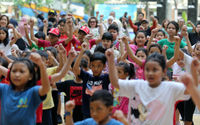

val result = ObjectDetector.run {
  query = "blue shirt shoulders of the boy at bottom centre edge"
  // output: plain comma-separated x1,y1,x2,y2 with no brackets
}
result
74,118,123,125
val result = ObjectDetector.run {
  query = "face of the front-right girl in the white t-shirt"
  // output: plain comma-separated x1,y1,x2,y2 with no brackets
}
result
144,61,165,87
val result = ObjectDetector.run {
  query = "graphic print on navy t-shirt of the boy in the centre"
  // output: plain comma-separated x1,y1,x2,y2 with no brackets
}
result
85,80,103,96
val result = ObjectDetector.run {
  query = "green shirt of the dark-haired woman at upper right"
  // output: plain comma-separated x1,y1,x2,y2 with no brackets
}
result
158,39,187,60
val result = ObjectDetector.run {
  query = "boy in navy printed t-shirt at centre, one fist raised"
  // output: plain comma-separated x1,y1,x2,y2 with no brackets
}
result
73,43,110,118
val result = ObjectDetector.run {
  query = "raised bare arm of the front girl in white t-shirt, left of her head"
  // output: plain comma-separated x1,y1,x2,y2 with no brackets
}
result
106,49,119,89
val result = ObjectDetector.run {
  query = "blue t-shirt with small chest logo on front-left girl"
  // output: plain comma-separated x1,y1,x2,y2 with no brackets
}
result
0,84,42,125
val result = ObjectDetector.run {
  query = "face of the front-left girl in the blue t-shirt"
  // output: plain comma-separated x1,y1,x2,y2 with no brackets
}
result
10,62,32,89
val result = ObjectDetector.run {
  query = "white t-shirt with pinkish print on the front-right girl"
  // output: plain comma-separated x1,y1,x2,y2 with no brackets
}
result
119,80,189,125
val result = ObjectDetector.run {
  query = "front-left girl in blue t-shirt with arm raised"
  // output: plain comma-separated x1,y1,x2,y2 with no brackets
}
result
0,53,50,125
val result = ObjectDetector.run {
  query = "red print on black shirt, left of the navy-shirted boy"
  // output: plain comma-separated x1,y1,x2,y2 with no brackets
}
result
70,86,82,105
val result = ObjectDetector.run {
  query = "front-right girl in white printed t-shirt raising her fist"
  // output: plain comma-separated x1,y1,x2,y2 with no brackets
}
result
106,49,192,125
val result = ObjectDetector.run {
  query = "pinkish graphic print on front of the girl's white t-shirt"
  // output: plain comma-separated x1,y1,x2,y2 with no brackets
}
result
130,94,166,125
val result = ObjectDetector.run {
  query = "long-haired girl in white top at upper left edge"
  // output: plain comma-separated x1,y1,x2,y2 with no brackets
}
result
0,27,18,55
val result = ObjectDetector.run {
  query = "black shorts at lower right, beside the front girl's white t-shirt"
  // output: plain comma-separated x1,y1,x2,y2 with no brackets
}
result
177,98,195,122
